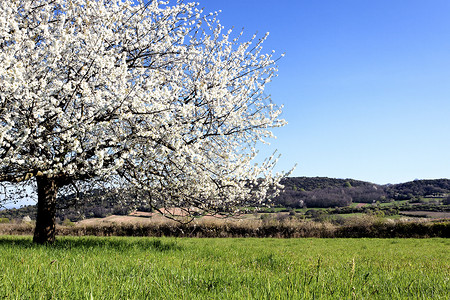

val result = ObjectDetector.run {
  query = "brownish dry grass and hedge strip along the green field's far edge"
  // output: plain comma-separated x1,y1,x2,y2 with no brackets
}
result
0,215,450,238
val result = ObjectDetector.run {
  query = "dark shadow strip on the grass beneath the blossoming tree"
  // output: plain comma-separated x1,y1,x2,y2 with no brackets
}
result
0,236,182,252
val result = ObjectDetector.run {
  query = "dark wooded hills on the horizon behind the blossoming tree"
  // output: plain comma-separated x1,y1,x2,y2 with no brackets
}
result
0,177,450,221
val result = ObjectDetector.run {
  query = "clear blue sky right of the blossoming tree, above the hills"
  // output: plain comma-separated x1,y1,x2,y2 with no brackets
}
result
200,0,450,184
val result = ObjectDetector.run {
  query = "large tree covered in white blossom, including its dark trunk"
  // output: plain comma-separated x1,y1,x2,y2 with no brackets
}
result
0,0,285,243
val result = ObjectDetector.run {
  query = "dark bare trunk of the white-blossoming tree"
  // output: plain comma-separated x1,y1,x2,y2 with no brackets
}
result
33,176,58,244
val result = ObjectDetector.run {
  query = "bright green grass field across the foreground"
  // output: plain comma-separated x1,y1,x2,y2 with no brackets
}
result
0,236,450,299
